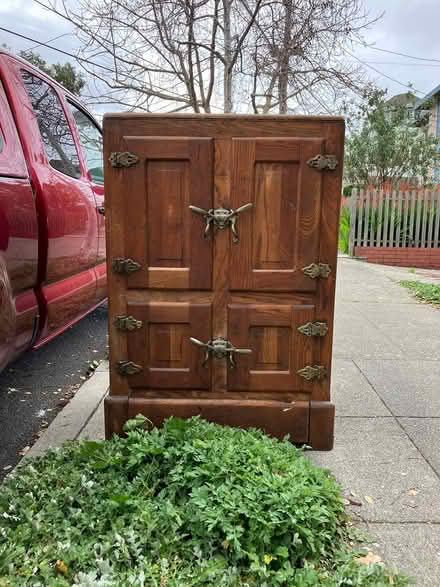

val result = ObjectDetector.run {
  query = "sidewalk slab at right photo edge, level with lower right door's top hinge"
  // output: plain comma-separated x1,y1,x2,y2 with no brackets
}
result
358,302,440,361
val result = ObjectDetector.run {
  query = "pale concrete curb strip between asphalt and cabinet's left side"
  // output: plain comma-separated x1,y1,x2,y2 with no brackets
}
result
20,361,109,468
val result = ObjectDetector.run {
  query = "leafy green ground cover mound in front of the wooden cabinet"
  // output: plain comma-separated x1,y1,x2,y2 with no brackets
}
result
0,416,409,587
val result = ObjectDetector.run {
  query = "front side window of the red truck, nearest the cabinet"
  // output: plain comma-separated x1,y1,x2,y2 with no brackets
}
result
68,102,104,184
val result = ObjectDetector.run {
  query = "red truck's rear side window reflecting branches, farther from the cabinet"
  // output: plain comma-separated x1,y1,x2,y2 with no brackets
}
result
21,70,81,178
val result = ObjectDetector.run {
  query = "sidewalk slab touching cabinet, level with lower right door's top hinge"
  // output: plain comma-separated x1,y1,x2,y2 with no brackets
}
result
333,302,403,359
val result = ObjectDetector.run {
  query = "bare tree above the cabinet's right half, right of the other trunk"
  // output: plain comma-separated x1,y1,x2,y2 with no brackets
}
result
249,0,370,114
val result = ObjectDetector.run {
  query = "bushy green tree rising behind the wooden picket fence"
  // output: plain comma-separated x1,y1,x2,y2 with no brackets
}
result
344,90,440,189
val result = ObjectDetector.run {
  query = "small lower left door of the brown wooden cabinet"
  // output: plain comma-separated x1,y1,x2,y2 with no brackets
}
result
125,302,211,389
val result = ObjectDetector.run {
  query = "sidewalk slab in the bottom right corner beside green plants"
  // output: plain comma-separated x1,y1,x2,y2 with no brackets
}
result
356,524,440,587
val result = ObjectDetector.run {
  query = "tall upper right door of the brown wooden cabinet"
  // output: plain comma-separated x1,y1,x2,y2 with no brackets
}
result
230,138,325,292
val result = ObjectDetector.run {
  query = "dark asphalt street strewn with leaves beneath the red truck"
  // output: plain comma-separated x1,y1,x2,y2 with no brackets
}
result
0,306,108,479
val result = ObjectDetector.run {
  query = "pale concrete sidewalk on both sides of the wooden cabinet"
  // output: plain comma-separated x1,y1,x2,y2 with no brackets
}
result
18,259,440,587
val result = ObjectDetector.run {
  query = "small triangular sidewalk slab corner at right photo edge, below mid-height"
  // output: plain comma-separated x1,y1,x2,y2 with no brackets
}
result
398,418,440,478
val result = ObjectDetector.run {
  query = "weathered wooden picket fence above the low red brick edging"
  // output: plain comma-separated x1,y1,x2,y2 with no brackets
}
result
347,190,440,255
